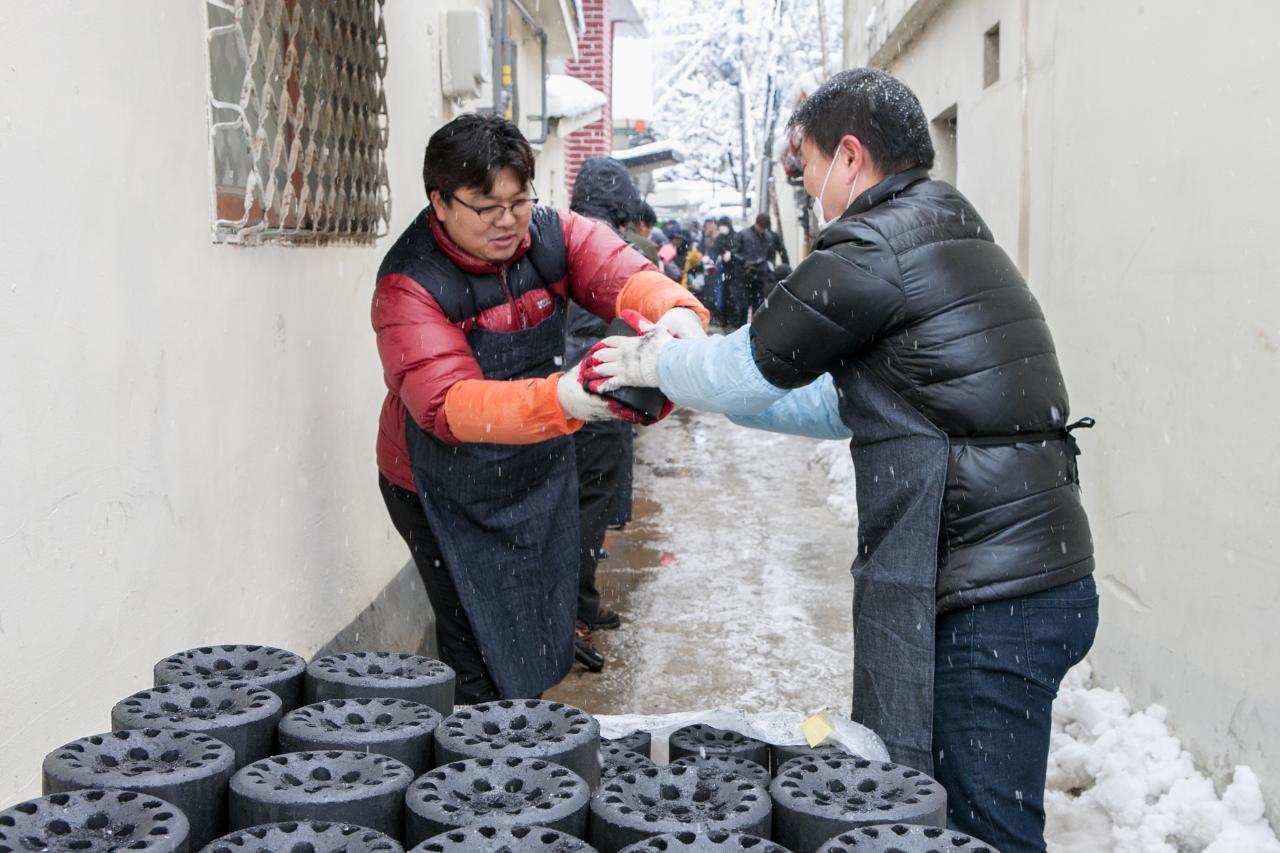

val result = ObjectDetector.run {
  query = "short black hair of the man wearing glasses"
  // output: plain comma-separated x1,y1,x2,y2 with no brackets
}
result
422,113,534,201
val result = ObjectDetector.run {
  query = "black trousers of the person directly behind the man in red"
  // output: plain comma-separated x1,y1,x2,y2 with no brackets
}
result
573,420,625,621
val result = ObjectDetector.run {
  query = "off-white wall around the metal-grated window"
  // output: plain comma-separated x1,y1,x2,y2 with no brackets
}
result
0,0,570,806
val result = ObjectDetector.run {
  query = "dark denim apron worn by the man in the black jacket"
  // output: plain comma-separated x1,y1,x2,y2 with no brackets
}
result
832,362,950,774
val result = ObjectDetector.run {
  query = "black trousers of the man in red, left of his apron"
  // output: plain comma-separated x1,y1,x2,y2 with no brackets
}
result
378,474,502,704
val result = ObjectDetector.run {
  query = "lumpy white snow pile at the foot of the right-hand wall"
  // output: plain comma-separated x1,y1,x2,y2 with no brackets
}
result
1044,661,1280,853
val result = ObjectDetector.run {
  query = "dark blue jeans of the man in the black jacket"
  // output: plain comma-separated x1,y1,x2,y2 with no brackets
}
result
933,576,1098,853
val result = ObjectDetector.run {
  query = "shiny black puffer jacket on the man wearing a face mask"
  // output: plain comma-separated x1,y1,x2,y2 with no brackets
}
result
751,169,1093,610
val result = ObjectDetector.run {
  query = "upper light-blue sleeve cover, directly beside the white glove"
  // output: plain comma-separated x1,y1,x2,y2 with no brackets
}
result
658,325,787,415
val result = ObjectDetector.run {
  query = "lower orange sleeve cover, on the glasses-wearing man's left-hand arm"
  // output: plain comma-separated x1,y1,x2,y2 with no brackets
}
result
444,373,582,444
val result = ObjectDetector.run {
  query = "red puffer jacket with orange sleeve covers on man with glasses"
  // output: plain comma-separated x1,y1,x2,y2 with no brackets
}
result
372,204,708,491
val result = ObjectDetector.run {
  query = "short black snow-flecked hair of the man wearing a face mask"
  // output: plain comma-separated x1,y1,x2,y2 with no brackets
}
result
787,68,933,175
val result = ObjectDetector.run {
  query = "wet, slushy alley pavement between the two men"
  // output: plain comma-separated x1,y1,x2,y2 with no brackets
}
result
547,411,855,713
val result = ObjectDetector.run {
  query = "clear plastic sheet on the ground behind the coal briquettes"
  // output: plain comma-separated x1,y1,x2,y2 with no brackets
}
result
595,708,890,765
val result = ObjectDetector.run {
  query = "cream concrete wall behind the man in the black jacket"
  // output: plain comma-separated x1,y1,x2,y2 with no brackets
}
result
846,0,1280,813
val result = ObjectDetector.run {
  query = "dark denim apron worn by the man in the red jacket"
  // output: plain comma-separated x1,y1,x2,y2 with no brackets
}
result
406,298,579,699
